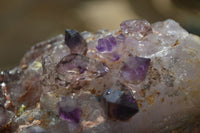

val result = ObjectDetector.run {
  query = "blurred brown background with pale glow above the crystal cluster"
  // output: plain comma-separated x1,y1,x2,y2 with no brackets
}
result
0,0,200,69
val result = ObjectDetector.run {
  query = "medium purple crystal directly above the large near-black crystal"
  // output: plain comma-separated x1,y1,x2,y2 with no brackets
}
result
121,56,151,84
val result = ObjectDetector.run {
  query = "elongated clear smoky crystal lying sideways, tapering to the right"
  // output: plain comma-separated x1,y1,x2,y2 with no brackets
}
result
56,54,109,82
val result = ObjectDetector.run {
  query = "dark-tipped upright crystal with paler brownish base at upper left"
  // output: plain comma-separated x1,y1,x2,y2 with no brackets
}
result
65,29,87,54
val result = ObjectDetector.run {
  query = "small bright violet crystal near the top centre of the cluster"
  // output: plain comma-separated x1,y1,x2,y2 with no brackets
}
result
96,35,117,52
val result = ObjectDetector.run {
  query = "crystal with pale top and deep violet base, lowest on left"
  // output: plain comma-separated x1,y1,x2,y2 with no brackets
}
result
58,97,82,123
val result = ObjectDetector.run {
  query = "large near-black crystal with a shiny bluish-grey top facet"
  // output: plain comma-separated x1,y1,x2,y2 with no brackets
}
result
103,89,139,120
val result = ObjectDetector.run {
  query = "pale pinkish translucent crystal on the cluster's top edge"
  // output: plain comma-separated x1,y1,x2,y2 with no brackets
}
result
120,20,152,39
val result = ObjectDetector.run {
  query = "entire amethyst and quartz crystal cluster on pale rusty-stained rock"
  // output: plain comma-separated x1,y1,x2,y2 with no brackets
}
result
0,19,200,133
